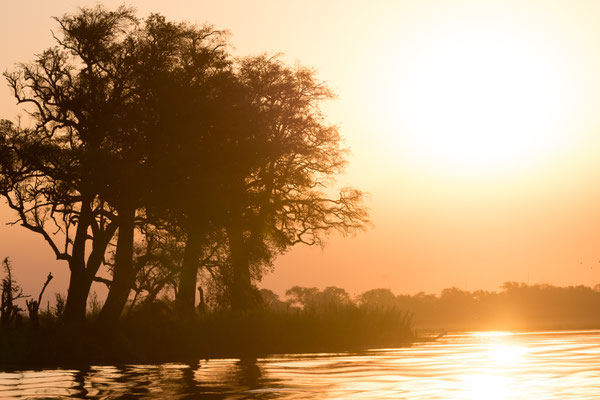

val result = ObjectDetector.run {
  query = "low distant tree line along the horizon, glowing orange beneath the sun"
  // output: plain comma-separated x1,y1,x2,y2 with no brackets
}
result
261,282,600,330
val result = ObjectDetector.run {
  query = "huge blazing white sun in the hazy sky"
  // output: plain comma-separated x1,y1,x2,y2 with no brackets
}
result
379,4,581,174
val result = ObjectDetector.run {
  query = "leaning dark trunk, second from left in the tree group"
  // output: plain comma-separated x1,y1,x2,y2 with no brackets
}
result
98,205,135,326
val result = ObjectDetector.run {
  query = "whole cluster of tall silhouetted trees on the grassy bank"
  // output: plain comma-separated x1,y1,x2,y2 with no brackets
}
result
0,6,368,325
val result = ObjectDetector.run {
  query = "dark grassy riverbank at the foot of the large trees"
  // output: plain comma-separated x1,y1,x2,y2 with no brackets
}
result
0,308,419,369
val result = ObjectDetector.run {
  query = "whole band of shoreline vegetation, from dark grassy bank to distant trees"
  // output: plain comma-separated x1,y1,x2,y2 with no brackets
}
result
0,276,600,369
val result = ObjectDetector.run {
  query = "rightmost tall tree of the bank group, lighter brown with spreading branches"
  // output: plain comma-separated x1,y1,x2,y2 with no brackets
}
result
218,56,368,310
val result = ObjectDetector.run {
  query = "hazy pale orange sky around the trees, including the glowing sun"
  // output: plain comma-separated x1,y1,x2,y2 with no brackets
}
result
0,0,600,300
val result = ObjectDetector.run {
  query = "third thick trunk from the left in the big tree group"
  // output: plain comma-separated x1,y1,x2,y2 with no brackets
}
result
175,229,202,317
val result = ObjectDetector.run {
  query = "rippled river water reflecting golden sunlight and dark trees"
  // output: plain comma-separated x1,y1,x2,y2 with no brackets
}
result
0,331,600,400
